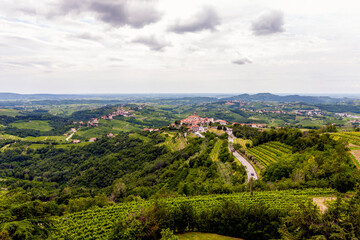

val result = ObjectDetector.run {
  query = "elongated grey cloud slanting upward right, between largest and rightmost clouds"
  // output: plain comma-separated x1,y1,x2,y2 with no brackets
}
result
168,7,220,33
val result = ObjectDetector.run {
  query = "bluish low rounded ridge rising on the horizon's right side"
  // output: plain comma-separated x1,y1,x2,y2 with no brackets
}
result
223,93,355,104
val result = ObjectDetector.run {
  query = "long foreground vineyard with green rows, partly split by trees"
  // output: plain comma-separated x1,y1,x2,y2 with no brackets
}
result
53,188,335,239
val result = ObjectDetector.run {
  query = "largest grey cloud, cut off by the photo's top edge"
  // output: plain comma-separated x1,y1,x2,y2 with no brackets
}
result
58,0,162,28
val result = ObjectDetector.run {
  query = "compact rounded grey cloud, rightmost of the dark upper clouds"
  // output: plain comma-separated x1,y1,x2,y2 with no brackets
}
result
251,11,285,35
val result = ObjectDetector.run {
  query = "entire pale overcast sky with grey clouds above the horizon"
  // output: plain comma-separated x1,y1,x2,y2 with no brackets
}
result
0,0,360,94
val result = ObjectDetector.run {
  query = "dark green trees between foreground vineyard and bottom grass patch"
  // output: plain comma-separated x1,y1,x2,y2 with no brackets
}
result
110,201,286,240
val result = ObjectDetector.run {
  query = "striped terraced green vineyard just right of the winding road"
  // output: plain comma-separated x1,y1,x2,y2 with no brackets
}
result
246,142,291,167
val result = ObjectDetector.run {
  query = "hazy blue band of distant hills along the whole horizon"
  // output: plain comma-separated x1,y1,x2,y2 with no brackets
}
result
0,93,355,104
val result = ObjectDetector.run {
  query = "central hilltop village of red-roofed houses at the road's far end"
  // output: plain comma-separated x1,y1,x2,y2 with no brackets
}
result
171,113,227,132
